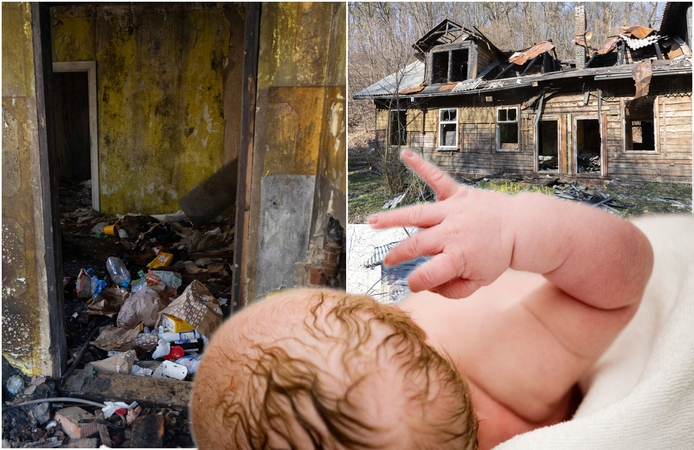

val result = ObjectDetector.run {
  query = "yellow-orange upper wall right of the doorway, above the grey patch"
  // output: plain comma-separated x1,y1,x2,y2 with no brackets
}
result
256,3,346,185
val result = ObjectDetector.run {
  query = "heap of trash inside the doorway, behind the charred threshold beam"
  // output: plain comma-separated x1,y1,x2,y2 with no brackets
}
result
62,206,234,380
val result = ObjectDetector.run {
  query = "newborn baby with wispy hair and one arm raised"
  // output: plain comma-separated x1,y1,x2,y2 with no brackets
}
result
192,151,653,449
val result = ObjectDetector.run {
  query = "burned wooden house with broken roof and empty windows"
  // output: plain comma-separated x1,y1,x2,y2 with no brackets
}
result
353,3,692,182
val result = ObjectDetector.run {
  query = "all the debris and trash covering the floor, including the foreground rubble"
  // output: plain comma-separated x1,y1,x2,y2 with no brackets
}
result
3,183,234,448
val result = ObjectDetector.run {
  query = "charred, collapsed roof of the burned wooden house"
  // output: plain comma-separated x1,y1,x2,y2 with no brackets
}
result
353,7,692,99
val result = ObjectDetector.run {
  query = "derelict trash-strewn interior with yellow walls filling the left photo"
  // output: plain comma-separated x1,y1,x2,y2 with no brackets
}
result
2,3,346,447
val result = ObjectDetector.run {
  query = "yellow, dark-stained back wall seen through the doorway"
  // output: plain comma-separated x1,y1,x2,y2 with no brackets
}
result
53,4,230,214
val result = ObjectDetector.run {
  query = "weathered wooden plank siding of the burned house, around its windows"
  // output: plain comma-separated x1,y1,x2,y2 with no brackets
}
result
377,84,693,183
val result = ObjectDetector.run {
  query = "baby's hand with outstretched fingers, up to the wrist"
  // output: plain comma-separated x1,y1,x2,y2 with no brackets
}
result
369,150,514,298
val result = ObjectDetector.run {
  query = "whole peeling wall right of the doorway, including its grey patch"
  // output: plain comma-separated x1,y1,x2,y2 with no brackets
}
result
246,3,346,299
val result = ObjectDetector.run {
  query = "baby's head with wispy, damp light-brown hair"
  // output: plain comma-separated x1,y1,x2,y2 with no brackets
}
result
192,289,477,449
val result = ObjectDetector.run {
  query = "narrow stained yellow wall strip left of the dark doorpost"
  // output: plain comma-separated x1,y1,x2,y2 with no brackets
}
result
2,3,55,375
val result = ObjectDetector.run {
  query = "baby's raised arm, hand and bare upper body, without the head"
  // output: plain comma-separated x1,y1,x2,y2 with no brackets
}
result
370,152,653,422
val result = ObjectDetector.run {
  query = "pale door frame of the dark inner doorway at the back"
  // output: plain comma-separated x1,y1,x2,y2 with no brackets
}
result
53,61,99,211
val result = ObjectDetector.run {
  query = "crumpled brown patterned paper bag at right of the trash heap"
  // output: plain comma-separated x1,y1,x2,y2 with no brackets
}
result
156,280,223,338
